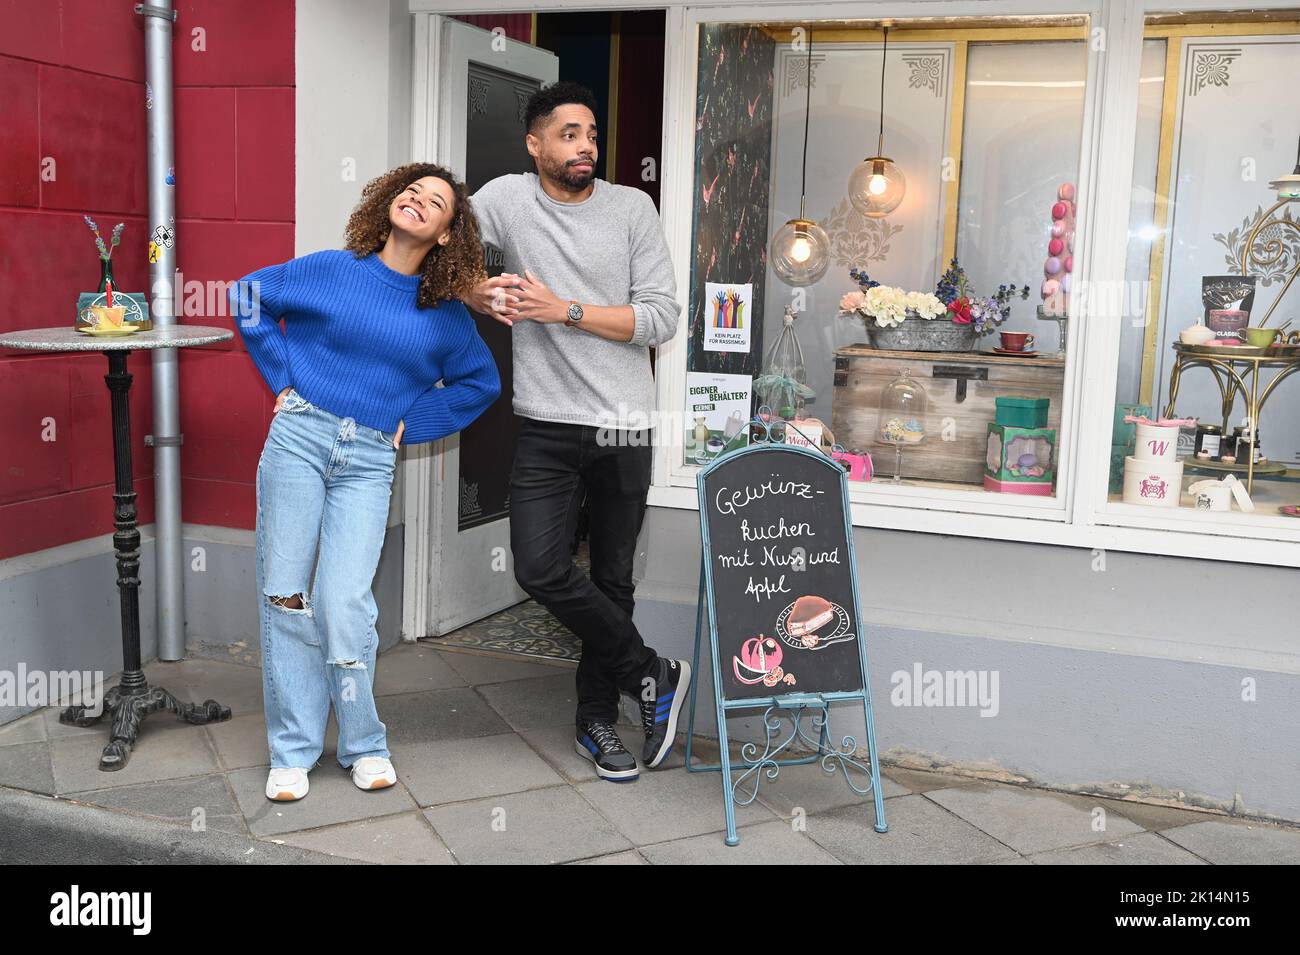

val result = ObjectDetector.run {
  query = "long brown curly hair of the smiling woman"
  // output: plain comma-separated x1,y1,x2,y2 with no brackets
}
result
343,162,488,308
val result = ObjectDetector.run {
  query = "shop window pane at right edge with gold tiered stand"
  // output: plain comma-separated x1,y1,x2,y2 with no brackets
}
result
1108,10,1300,531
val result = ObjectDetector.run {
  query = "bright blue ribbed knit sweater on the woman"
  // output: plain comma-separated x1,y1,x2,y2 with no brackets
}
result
230,251,501,444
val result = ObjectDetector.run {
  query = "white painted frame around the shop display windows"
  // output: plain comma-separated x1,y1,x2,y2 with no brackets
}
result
410,0,1300,567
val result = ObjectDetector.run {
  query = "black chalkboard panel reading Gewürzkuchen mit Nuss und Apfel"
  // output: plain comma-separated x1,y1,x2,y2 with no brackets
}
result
698,446,865,699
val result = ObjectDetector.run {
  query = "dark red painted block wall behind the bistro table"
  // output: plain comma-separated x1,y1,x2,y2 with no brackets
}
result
0,0,294,559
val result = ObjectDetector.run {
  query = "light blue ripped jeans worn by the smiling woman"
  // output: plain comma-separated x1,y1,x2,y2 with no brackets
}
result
256,391,398,769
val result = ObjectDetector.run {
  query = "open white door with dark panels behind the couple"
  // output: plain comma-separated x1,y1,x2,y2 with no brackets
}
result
403,14,559,639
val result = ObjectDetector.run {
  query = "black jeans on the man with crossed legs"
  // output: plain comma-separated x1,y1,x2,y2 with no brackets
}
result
510,418,658,722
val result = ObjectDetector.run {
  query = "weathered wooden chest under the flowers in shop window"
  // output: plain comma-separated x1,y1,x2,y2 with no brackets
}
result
831,344,1065,485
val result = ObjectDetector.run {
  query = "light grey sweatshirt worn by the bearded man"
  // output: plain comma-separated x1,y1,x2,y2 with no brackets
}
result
469,173,681,427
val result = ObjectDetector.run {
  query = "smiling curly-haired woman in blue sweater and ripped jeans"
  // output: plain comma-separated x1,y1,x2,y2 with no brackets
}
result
231,162,501,800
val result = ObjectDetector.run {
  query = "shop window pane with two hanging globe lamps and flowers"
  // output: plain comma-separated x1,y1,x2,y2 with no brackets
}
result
677,17,1089,507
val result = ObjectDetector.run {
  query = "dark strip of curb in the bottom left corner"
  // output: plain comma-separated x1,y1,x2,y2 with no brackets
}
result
0,786,356,865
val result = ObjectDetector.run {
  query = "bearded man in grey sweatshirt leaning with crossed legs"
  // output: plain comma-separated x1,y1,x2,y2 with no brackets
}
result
464,82,690,782
